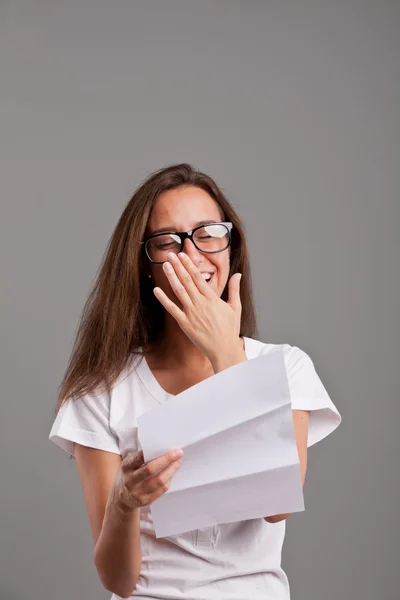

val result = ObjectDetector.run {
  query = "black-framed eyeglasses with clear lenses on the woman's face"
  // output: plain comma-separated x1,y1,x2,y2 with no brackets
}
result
140,222,233,264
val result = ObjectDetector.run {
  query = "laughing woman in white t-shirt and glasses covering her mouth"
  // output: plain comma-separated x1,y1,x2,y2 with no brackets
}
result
49,164,340,600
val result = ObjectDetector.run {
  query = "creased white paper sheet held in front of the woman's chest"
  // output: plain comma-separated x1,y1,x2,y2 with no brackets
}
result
138,349,304,537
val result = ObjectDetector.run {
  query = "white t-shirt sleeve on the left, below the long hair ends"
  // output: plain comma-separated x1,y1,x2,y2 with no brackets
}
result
49,393,120,456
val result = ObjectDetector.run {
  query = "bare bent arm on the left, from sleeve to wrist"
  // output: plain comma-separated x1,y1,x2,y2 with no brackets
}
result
75,444,142,598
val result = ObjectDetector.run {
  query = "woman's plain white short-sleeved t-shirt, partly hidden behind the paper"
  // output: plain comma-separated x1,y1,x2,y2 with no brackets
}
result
49,337,341,600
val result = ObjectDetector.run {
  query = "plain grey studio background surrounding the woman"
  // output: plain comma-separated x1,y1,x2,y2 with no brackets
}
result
0,0,400,600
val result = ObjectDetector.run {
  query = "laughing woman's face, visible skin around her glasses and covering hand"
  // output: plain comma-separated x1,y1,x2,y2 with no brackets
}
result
146,186,230,303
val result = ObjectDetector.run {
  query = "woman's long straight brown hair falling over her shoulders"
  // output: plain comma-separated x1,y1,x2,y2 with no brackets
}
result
56,163,257,411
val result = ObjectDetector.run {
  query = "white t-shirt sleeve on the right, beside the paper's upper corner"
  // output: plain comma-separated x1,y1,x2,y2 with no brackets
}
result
286,346,342,446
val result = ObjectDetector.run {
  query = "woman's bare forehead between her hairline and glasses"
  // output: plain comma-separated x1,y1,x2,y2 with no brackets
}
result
148,187,222,231
